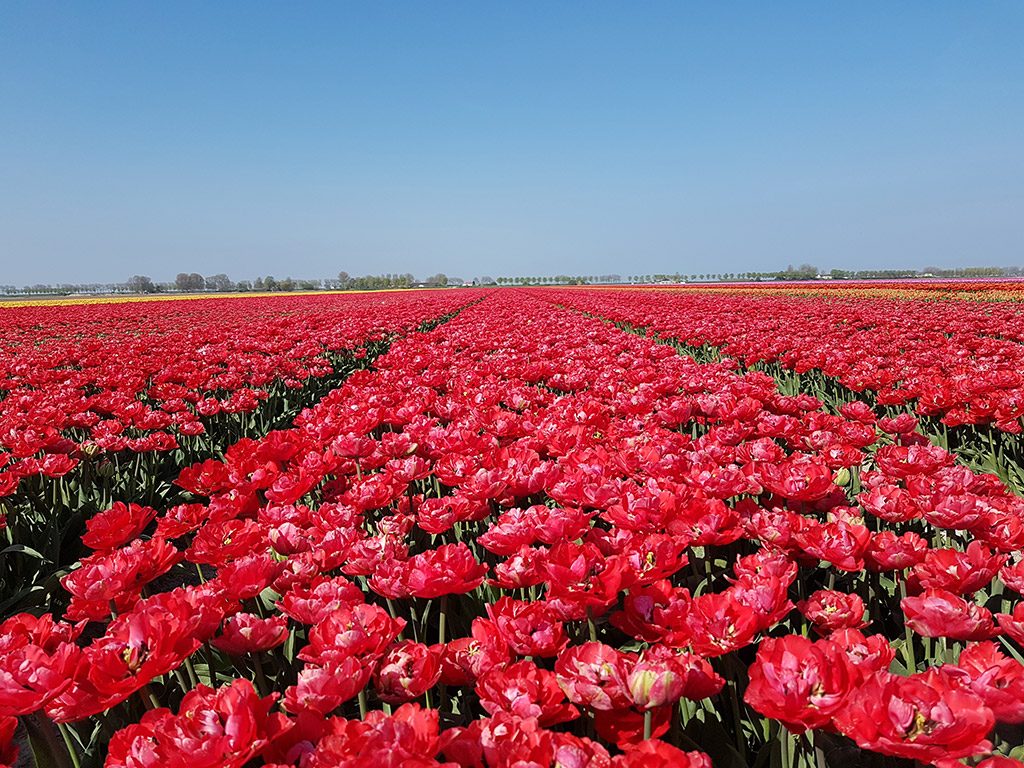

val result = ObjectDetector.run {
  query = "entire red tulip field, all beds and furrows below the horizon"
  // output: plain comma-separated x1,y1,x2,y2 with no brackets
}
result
0,283,1024,768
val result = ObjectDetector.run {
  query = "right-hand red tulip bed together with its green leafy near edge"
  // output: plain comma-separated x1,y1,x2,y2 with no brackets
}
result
544,284,1024,495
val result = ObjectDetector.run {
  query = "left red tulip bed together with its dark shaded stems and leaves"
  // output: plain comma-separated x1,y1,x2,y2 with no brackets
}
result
0,292,482,617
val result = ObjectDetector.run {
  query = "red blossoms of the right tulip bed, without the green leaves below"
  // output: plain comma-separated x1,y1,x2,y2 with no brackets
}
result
543,290,1024,434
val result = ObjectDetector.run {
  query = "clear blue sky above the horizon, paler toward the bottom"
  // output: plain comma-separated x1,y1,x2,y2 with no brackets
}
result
0,0,1024,285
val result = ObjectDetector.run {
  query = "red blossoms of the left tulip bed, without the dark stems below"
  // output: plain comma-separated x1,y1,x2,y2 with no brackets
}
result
0,292,478,496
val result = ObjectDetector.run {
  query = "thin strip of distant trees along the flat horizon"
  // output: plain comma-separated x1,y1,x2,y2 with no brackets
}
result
6,264,1024,296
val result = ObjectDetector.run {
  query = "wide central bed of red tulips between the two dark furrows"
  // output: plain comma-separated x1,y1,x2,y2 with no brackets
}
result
0,291,1024,768
